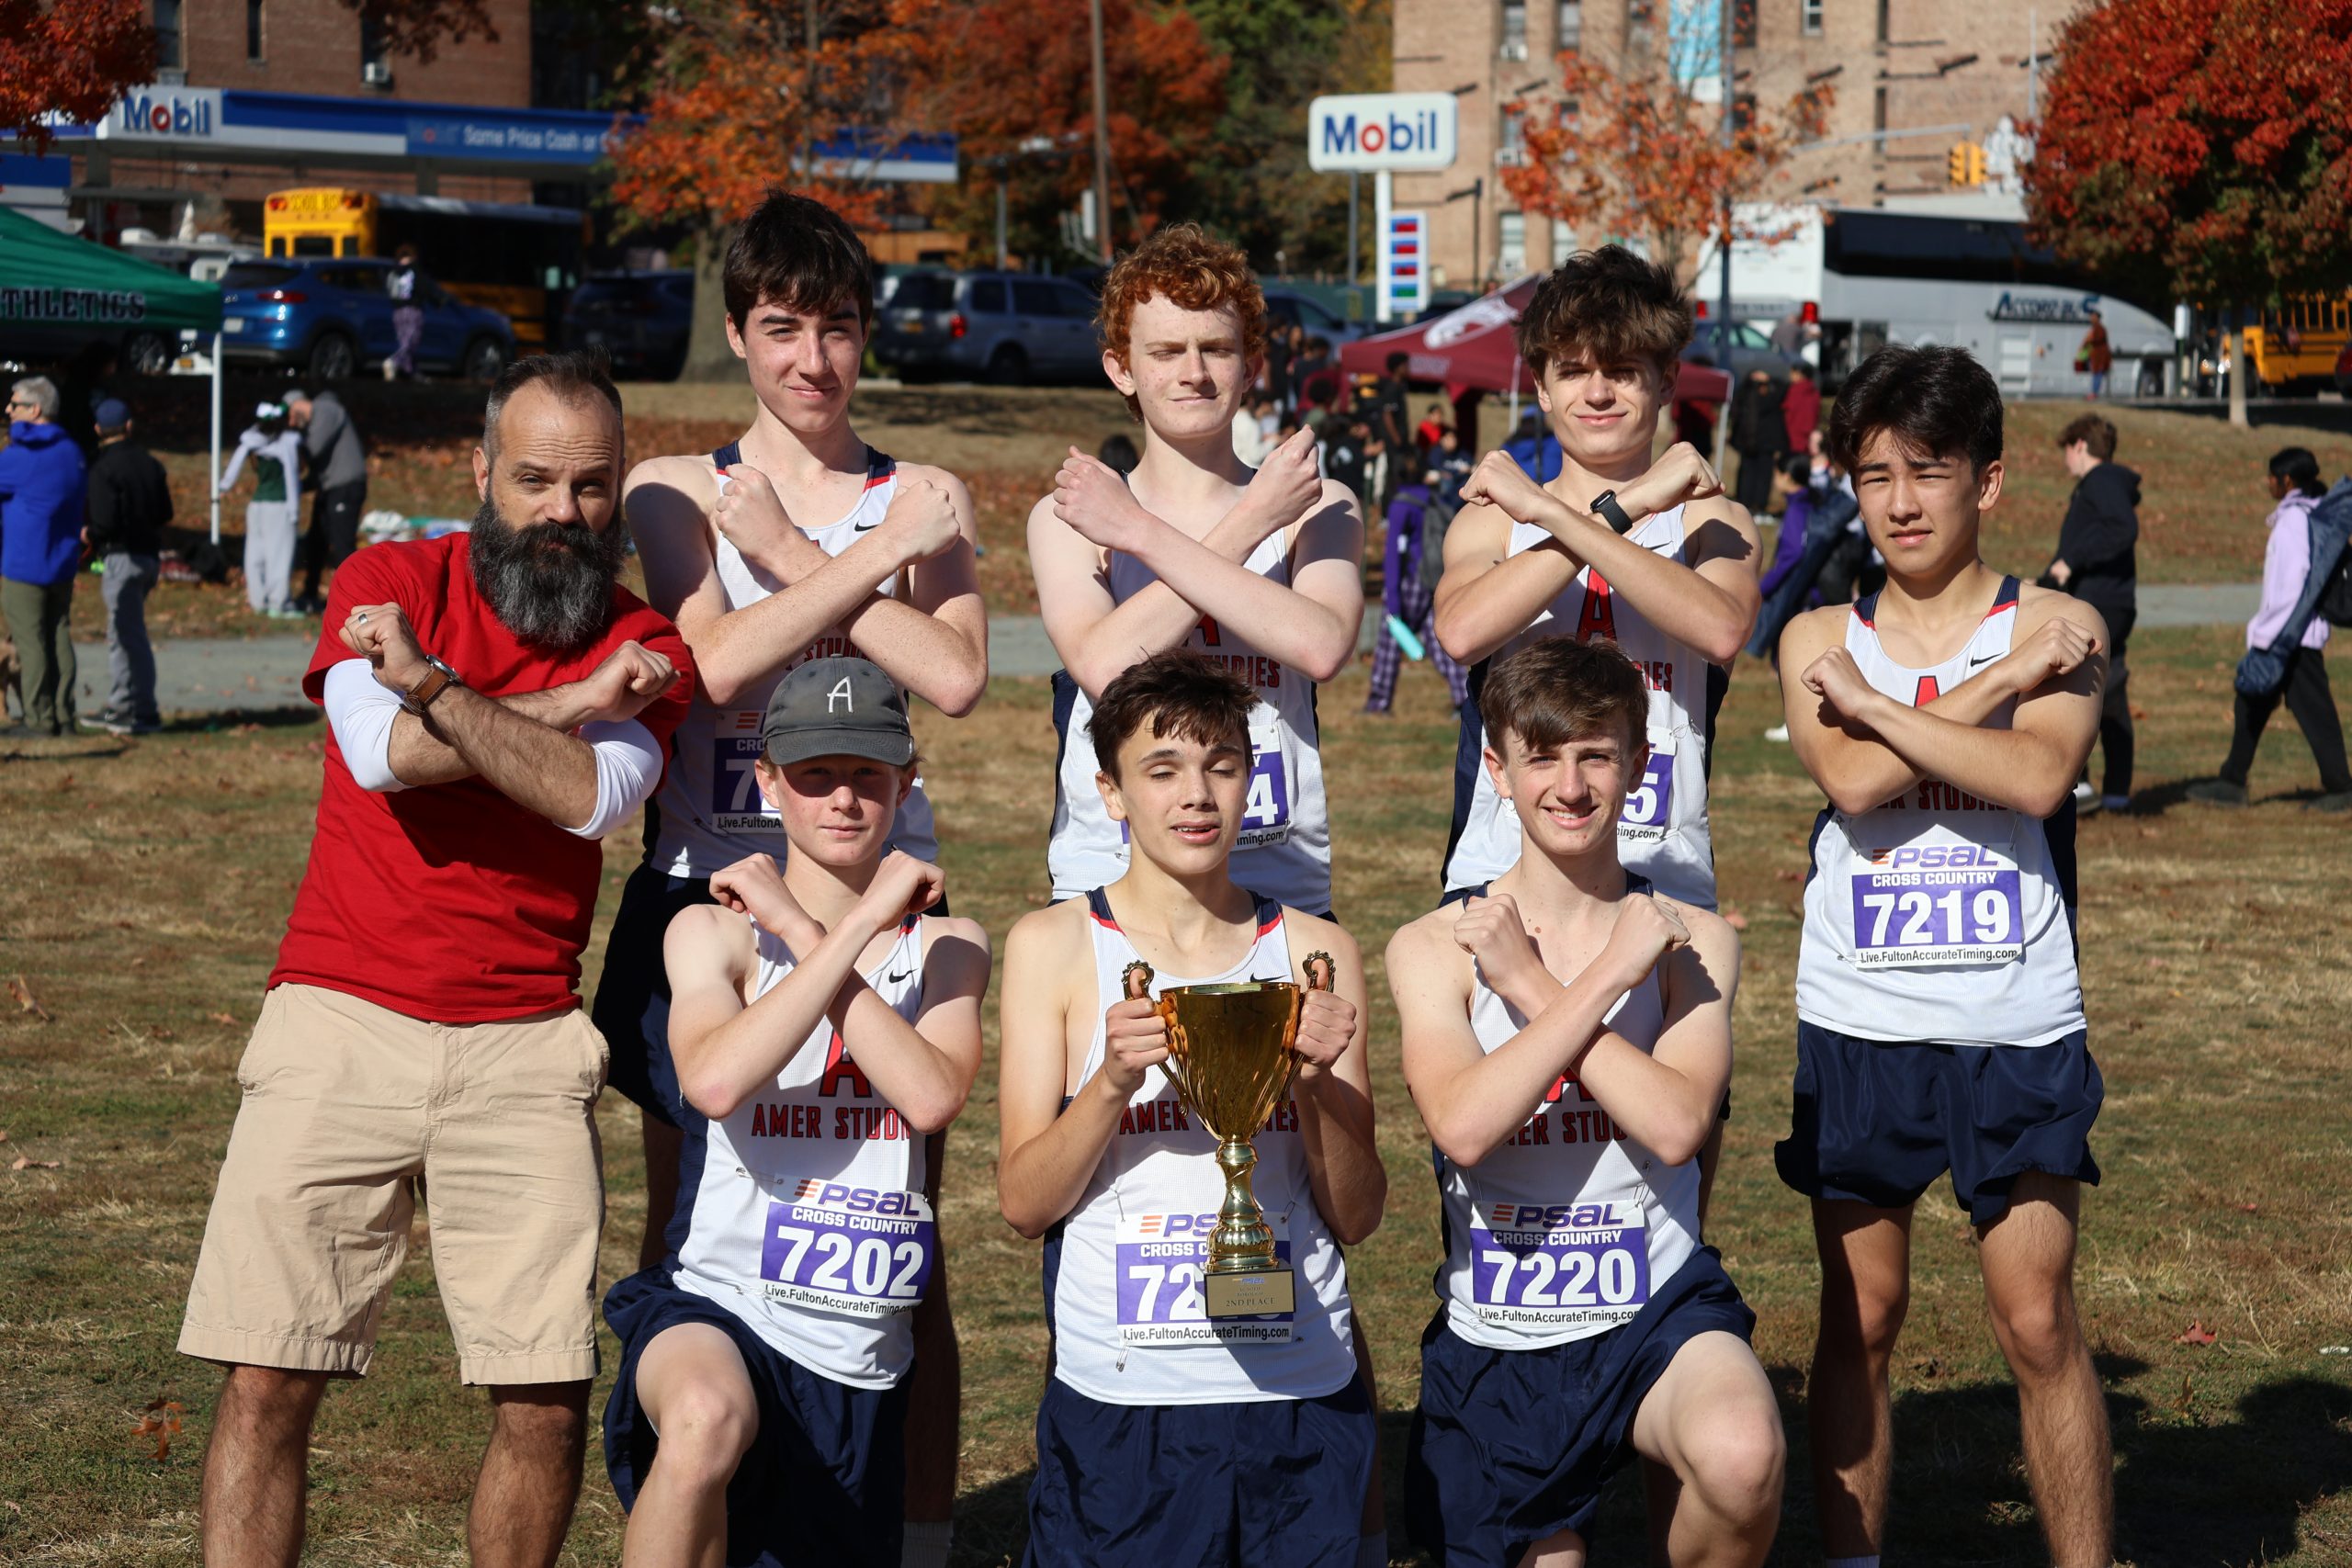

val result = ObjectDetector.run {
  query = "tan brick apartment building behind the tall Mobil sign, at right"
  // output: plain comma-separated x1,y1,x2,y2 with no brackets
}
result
1393,0,2072,287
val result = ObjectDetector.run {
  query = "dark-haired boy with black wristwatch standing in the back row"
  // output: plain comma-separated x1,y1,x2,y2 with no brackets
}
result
1437,244,1761,909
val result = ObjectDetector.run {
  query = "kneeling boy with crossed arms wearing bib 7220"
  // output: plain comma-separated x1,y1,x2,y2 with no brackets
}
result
1387,637,1785,1568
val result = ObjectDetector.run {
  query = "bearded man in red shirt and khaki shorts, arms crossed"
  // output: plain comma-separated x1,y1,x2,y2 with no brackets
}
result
179,355,694,1568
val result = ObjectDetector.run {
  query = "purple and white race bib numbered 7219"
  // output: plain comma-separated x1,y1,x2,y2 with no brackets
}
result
1851,829,2025,968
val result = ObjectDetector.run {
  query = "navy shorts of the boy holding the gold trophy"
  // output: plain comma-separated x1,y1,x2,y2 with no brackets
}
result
1023,1352,1381,1568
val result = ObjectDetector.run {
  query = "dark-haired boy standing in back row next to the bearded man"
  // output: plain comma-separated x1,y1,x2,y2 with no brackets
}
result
595,195,988,1563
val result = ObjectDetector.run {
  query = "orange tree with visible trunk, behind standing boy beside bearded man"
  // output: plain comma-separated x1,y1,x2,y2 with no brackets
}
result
612,0,945,378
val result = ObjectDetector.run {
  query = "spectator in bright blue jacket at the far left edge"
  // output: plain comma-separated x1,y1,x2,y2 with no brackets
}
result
0,376,89,736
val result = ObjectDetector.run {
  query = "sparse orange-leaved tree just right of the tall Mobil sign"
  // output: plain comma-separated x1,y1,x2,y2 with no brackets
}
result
1500,7,1830,287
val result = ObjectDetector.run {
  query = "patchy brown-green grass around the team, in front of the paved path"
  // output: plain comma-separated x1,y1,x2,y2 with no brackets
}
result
0,630,2352,1568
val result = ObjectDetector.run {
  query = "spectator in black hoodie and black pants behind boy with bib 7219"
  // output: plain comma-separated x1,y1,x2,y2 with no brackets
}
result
2041,413,2141,811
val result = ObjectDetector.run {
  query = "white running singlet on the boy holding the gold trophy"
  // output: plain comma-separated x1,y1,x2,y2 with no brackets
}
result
1045,888,1355,1405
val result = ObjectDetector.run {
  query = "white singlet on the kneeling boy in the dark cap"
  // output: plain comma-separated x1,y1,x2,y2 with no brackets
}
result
671,917,938,1389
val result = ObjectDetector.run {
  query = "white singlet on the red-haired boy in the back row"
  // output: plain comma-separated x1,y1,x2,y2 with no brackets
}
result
1045,534,1331,915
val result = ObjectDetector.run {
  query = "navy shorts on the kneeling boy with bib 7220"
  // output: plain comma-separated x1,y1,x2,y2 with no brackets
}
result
1404,1246,1757,1568
